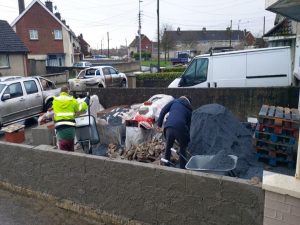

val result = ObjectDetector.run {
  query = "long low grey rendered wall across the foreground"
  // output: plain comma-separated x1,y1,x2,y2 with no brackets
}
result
0,142,264,225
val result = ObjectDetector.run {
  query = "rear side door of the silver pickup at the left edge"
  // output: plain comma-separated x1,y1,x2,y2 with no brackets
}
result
24,80,43,115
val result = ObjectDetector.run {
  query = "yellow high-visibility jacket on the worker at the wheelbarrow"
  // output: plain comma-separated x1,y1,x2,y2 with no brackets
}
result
52,92,88,127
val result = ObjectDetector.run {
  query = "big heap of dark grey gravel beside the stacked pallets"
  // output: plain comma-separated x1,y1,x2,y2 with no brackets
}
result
188,104,262,178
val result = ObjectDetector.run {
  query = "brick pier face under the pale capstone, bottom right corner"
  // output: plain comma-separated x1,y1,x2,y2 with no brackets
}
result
264,191,300,225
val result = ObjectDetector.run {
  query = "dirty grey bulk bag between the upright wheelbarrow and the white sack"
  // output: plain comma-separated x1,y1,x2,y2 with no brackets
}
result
97,119,125,145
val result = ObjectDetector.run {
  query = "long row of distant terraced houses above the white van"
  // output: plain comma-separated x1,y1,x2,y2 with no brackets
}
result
161,27,255,57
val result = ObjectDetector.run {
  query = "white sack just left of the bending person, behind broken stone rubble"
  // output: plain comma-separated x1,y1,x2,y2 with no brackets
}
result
125,127,155,150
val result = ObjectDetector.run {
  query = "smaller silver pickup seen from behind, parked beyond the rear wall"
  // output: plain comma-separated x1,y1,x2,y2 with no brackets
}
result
68,66,128,91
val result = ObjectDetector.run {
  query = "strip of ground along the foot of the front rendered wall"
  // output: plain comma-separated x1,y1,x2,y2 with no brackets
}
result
0,189,104,225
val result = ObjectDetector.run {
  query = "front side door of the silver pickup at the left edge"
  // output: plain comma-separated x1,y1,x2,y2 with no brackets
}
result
1,82,27,123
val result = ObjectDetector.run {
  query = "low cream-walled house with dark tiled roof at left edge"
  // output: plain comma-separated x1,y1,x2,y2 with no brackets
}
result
0,20,29,76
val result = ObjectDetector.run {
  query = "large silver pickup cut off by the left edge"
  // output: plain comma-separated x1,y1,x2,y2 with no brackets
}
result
0,76,60,128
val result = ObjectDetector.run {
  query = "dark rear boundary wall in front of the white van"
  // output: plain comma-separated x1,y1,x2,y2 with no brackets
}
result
89,87,299,121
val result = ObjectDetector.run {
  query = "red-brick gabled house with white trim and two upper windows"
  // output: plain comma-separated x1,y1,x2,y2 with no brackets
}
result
11,0,79,74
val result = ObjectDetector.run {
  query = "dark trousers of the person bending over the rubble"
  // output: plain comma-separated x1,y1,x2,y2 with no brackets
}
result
165,127,188,169
